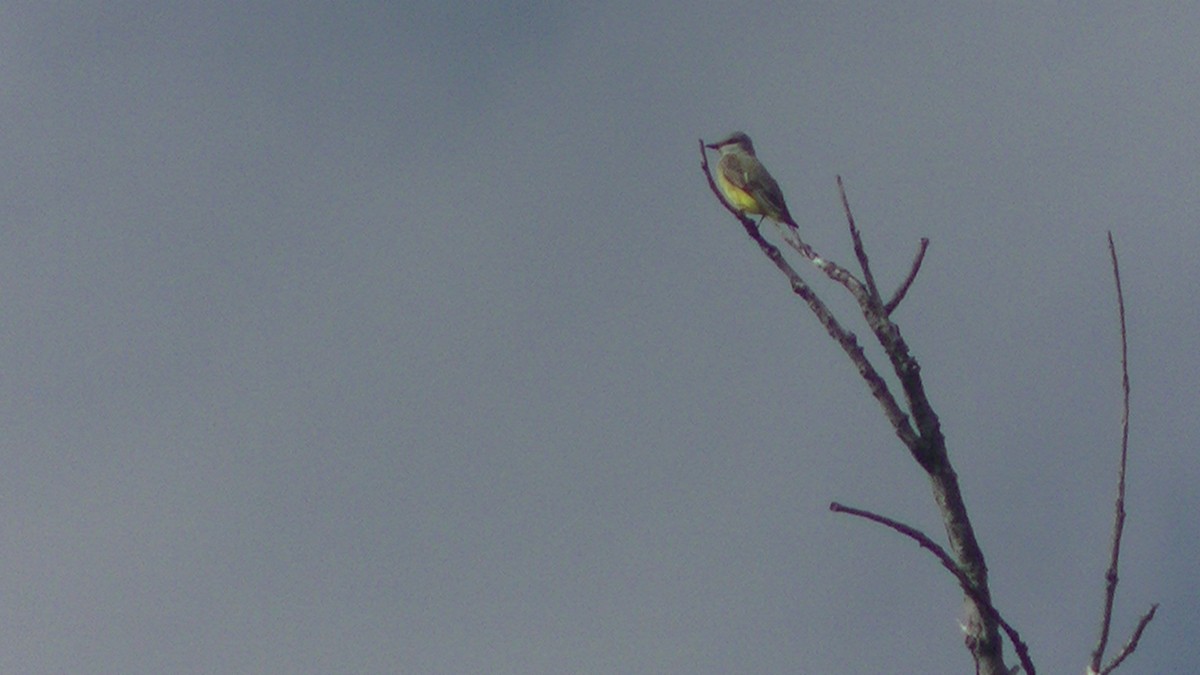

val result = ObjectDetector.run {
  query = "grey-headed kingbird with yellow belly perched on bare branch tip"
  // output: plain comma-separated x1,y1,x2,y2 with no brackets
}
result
706,131,798,229
